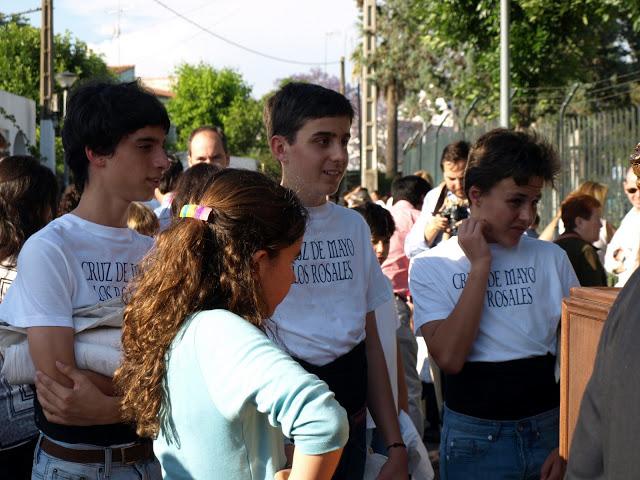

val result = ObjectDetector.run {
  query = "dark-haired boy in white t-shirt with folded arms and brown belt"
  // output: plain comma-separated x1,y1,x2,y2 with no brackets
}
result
0,82,169,479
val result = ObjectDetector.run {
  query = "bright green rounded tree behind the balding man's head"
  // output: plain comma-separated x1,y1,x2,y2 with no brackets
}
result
167,63,255,150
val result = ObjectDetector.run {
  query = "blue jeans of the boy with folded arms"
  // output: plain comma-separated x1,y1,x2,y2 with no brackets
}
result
31,436,162,480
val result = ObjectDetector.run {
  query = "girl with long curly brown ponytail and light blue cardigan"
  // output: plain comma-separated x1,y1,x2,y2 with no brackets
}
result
116,169,347,480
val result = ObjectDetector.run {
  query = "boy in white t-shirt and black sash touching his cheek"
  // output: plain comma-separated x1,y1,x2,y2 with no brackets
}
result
409,129,579,480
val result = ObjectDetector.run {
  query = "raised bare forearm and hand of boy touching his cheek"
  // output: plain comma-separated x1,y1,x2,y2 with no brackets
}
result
420,218,491,373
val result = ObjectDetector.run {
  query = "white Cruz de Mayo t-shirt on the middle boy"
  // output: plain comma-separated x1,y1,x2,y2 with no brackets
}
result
269,202,392,366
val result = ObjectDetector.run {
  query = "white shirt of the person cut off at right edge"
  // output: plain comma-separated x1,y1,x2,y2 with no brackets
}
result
604,208,640,287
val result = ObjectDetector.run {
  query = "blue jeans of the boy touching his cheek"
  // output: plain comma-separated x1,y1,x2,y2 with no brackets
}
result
440,405,560,480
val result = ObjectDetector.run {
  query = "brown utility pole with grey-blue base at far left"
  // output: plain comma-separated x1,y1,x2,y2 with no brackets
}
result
40,0,56,173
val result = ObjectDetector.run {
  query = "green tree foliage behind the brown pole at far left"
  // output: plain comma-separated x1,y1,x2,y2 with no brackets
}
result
0,17,111,110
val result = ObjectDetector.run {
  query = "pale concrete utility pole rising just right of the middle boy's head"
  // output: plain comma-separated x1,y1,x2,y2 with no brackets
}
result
360,0,378,191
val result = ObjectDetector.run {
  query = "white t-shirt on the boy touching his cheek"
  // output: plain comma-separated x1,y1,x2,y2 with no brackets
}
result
409,236,580,362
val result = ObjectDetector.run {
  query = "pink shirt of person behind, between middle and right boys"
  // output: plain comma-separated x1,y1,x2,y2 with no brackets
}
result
382,200,420,295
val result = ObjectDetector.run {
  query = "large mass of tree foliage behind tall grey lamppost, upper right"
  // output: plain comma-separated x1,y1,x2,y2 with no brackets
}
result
375,0,640,125
